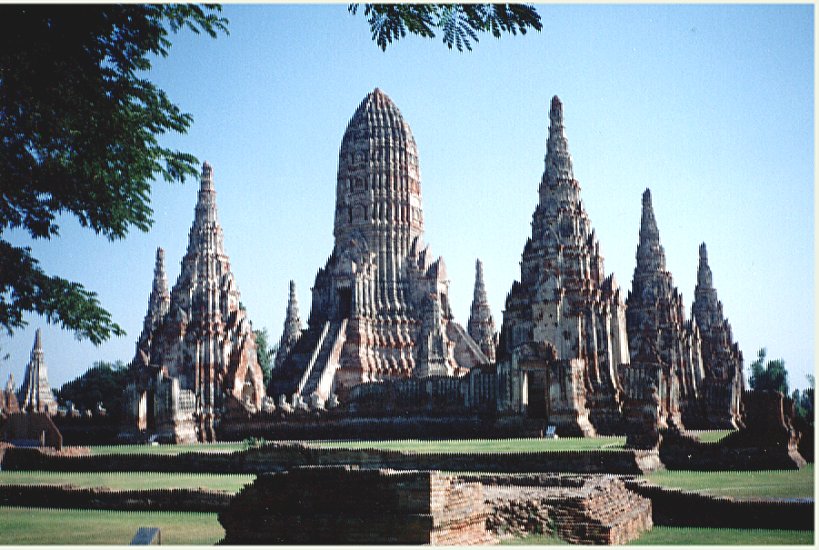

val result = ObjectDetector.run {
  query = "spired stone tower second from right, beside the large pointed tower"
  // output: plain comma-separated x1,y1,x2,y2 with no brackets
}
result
624,189,706,429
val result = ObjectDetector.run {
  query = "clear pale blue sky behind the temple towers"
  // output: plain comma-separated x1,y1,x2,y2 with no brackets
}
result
0,5,815,394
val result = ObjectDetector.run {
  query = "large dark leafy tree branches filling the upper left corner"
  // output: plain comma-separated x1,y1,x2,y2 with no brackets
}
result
0,4,227,344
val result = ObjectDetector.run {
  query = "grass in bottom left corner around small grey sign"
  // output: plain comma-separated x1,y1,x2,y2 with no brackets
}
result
0,506,225,546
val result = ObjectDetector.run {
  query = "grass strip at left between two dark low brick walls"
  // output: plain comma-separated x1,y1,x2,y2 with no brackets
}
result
0,471,256,493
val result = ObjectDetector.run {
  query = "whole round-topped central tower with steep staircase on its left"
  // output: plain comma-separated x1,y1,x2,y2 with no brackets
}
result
269,88,488,405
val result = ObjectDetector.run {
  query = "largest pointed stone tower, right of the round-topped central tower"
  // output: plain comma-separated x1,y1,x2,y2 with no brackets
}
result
497,96,629,435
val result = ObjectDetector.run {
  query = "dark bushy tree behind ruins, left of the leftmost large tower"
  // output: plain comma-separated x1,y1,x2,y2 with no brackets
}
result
56,361,128,418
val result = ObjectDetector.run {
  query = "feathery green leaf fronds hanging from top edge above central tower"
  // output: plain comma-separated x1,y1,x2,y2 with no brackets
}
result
348,4,543,52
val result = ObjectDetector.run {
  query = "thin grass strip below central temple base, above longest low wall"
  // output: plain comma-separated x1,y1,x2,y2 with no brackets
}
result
307,437,626,453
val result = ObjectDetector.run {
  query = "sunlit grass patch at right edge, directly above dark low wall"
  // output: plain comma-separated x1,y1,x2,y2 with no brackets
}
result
645,464,814,498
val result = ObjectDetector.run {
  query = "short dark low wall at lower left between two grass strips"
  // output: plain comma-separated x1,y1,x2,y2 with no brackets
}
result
0,485,233,512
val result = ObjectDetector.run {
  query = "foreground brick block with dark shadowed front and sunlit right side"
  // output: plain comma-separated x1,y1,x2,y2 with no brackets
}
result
219,467,493,545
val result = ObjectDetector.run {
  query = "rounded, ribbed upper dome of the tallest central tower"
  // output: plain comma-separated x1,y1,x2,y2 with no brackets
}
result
333,88,424,255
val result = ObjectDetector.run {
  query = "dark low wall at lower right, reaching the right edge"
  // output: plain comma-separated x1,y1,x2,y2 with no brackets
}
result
625,480,814,531
